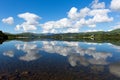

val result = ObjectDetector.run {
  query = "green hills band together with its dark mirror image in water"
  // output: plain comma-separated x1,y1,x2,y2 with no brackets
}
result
0,29,120,45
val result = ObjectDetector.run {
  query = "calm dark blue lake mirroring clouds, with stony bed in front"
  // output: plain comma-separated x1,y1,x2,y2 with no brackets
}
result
0,40,120,80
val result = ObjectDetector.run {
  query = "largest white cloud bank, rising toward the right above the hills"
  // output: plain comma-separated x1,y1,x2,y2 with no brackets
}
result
41,0,113,33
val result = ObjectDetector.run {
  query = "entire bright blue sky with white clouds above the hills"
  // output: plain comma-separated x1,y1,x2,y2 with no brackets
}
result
0,0,120,33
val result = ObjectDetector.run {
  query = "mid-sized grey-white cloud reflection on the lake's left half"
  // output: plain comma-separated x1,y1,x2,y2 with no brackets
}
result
15,43,41,61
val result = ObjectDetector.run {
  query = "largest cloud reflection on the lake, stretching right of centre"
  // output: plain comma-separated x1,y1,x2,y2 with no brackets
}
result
42,41,112,66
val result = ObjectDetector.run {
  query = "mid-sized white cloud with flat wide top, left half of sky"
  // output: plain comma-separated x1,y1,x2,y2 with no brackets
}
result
15,12,41,32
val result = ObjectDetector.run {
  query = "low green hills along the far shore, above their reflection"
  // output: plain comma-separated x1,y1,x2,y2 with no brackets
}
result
5,29,120,40
